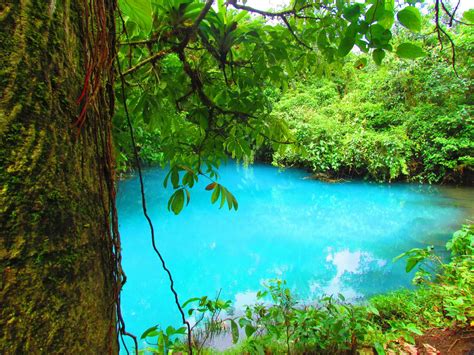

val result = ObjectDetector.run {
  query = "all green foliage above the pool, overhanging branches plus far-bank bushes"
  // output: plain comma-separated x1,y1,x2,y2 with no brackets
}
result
114,1,474,186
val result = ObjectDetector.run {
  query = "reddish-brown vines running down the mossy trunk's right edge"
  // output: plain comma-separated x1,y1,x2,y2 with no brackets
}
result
74,0,138,354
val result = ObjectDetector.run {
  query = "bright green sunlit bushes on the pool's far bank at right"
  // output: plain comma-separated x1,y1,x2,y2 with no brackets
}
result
274,22,474,182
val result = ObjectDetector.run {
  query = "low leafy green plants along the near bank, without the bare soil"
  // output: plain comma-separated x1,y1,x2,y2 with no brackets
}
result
143,225,474,354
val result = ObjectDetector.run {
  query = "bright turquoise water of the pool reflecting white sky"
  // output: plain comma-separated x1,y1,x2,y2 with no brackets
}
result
118,164,474,348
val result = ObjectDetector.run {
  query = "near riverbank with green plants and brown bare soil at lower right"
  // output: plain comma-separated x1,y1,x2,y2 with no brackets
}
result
156,225,474,355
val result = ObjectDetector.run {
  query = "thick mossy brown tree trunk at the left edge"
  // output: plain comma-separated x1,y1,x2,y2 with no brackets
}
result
0,0,118,354
